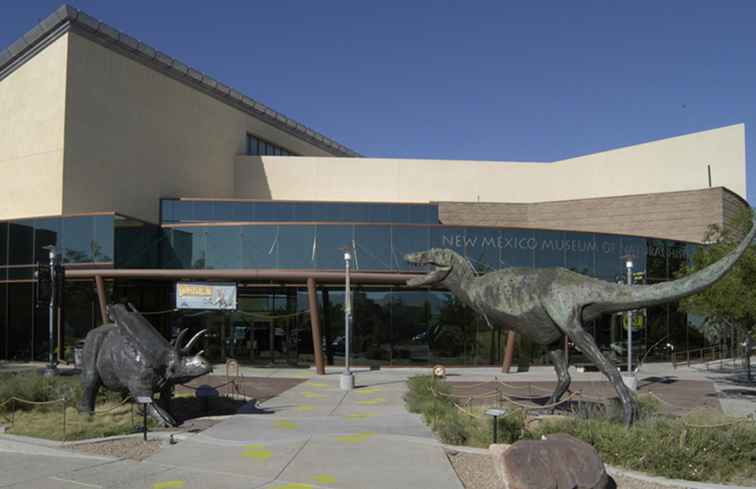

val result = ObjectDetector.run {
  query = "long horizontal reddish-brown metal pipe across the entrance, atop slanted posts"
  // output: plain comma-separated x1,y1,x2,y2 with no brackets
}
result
66,268,420,285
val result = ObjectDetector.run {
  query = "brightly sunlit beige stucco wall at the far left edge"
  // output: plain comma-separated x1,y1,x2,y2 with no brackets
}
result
0,36,68,219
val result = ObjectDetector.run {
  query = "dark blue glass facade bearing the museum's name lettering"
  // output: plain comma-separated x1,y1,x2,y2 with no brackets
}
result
0,199,705,365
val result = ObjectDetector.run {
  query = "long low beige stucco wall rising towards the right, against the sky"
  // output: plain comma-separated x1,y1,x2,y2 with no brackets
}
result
235,124,746,203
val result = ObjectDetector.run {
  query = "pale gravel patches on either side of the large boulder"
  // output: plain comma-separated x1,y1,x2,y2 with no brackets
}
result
447,452,692,489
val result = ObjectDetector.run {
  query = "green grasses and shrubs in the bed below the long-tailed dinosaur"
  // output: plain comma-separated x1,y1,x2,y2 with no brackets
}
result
405,376,756,485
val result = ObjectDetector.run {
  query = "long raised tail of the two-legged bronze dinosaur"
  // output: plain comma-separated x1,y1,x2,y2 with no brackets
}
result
583,219,756,318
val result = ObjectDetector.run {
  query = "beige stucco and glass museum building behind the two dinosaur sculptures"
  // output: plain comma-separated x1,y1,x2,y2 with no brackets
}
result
0,6,748,366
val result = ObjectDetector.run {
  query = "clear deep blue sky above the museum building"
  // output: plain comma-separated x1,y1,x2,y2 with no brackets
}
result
0,0,756,200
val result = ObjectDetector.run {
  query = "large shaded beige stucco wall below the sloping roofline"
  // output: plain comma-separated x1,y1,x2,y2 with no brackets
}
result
63,33,336,221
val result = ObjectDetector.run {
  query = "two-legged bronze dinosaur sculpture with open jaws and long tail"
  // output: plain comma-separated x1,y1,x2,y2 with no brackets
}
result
405,215,756,426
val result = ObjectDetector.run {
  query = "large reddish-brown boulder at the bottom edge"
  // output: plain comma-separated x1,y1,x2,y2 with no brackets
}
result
490,433,610,489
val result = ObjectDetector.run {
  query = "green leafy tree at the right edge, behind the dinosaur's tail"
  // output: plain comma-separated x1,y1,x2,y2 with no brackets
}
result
680,208,756,382
